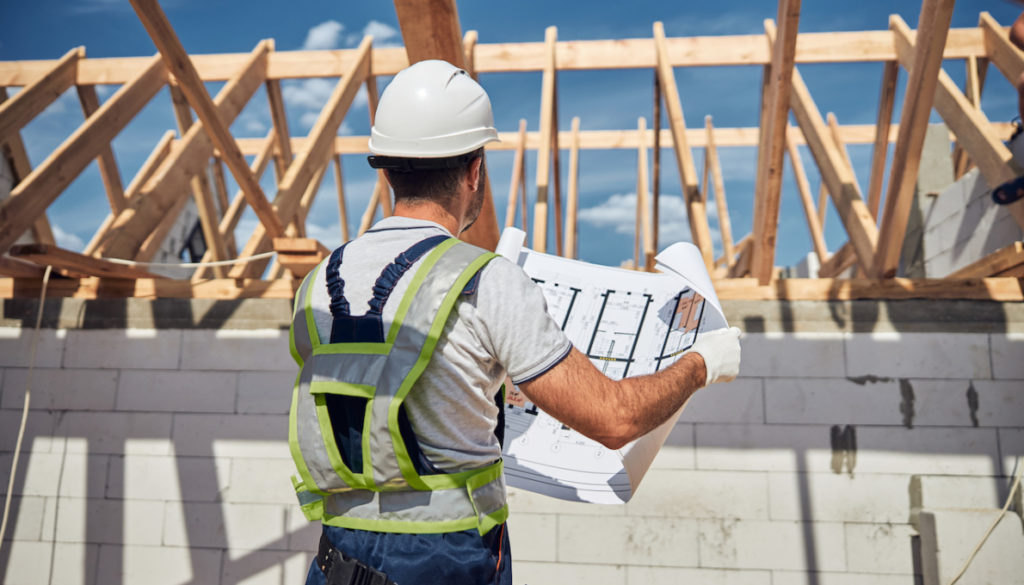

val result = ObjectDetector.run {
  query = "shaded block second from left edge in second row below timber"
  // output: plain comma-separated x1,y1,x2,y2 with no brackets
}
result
117,370,238,413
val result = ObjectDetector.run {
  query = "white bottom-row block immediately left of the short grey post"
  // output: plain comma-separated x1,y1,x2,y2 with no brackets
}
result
845,524,916,576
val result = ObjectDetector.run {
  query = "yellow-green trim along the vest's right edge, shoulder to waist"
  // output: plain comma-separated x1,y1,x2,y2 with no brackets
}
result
388,251,498,490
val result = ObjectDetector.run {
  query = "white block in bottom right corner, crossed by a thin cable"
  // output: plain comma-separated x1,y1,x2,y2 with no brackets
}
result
919,510,1024,585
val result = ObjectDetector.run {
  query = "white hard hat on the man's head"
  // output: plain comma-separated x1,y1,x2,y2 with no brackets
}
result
370,60,498,166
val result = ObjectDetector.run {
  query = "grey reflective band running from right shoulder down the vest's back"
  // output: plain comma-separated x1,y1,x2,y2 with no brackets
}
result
370,242,485,485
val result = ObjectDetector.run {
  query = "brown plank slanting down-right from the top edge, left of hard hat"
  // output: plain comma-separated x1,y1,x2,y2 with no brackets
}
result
130,0,285,240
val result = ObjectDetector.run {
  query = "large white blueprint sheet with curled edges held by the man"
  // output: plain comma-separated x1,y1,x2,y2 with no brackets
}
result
497,227,727,504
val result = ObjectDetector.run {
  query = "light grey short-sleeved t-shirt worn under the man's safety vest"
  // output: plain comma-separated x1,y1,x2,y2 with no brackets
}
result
303,216,570,472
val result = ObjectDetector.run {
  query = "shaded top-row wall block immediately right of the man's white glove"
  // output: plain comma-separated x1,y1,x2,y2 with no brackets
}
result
739,332,850,378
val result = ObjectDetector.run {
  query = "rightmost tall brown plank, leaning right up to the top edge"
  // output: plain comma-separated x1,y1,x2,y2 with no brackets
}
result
872,0,953,277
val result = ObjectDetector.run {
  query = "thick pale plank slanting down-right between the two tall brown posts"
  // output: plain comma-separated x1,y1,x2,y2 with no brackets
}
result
791,61,879,274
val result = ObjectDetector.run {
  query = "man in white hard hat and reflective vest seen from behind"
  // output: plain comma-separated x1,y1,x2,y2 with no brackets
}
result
289,60,739,585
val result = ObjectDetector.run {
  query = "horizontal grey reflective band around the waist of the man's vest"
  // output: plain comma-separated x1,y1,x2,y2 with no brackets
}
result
324,476,505,523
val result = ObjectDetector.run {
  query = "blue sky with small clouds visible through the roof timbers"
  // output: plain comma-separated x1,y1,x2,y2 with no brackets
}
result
0,0,1022,265
